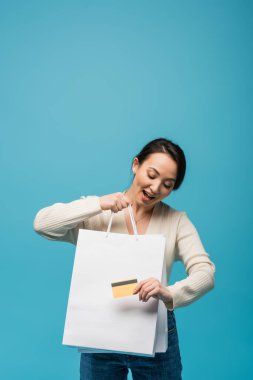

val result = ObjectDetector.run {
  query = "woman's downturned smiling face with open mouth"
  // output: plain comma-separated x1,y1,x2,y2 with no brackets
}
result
132,153,177,208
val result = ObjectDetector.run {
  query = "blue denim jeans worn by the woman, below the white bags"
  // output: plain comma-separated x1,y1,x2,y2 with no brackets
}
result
80,310,182,380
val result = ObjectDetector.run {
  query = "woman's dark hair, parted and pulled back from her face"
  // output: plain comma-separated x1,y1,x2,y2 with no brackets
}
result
132,138,186,190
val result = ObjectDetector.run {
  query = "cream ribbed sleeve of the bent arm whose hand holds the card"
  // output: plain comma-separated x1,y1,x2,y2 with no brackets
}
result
165,212,216,310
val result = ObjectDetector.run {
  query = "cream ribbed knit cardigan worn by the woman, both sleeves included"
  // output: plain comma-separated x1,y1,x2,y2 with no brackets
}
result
33,196,215,310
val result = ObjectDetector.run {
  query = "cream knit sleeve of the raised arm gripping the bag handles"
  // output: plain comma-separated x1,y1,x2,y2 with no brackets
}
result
33,196,102,245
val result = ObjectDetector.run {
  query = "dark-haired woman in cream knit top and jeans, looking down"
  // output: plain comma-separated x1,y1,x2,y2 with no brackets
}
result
34,138,215,380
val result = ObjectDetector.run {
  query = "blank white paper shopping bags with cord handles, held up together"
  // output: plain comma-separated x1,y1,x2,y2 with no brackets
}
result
62,206,167,356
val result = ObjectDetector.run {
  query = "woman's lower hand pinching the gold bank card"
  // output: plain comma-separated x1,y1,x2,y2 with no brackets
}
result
133,277,173,302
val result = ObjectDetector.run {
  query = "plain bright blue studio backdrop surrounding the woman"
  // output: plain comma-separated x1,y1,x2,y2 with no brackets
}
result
0,0,253,380
